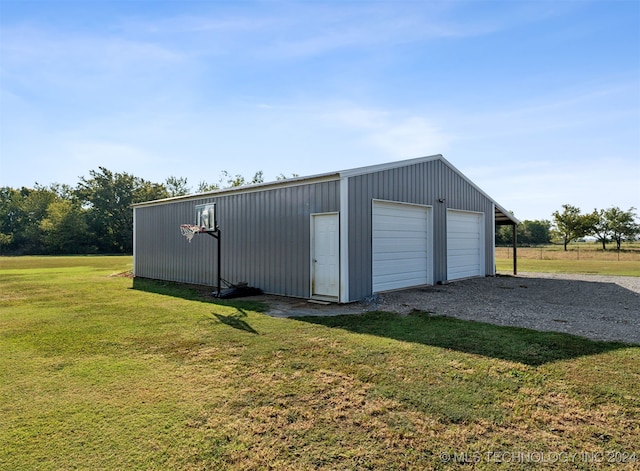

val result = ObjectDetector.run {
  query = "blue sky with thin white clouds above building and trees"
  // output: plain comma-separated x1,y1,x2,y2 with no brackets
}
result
0,0,640,219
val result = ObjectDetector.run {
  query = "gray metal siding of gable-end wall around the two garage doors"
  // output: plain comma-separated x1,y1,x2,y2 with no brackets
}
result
348,160,494,300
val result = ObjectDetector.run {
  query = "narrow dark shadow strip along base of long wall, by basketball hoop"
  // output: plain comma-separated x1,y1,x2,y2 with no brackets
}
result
131,278,269,317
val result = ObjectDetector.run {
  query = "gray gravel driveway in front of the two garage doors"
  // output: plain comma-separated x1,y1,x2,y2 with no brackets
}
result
267,273,640,344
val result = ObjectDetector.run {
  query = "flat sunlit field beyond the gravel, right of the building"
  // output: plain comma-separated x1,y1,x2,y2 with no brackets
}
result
496,243,640,276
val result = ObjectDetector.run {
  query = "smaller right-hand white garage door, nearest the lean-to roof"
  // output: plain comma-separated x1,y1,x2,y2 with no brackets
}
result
447,210,484,280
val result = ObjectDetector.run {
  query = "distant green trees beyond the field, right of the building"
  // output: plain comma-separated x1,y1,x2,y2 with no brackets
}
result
496,204,640,251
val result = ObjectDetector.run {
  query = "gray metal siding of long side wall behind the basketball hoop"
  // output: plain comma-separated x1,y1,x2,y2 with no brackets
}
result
134,180,340,297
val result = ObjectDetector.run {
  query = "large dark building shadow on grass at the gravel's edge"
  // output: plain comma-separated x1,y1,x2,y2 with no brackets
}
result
295,311,631,366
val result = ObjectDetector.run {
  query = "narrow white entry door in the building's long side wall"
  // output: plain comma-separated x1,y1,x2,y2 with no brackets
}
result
311,213,340,299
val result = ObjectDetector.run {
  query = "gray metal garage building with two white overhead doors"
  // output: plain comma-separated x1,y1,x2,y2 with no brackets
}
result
133,155,519,302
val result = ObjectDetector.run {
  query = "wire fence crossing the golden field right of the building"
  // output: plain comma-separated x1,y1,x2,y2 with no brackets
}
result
496,245,640,262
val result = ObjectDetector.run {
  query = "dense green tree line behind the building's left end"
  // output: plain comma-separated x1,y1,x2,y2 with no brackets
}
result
0,167,270,255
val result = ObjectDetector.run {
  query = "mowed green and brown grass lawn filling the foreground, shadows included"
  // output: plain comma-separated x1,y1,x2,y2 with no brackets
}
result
0,257,640,470
